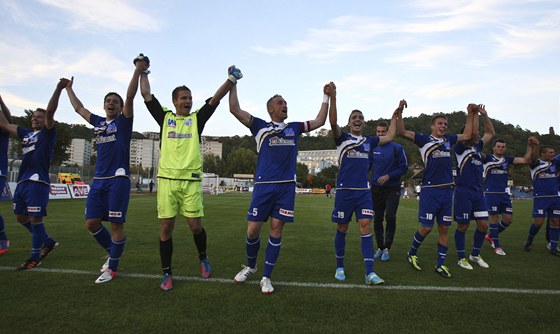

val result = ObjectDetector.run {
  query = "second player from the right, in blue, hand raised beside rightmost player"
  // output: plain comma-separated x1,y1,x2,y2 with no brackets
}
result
483,137,537,255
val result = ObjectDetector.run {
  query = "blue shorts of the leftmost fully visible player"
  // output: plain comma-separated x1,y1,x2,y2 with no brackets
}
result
14,180,51,217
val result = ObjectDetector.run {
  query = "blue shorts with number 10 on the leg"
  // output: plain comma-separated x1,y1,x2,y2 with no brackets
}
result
418,187,453,227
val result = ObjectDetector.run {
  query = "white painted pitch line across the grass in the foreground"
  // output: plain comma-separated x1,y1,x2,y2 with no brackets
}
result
0,266,560,295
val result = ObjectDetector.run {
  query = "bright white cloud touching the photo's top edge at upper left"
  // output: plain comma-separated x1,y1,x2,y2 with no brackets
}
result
39,0,161,31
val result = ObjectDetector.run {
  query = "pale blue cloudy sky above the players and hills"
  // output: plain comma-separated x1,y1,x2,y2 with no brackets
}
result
0,0,560,136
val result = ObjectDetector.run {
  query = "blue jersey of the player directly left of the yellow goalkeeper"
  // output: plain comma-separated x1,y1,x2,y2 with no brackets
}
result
89,114,132,179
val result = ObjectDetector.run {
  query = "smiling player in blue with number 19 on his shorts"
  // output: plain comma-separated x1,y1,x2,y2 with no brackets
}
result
329,89,406,285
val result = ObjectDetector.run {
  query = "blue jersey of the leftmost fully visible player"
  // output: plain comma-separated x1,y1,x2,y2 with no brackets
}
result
17,126,56,184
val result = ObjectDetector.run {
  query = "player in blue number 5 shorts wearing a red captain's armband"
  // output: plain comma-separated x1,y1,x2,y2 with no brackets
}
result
229,79,334,294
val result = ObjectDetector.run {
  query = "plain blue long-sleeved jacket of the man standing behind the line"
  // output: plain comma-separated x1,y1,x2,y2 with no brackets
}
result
371,142,408,187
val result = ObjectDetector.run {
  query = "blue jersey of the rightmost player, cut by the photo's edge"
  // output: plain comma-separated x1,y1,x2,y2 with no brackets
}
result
530,156,560,197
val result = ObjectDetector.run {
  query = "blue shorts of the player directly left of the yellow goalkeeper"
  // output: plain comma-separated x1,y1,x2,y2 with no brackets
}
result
86,177,130,223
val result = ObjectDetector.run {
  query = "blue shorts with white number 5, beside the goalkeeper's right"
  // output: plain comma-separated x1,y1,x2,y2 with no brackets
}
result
247,182,296,223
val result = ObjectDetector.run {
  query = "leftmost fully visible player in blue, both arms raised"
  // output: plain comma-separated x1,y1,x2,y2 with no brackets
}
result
0,79,68,270
